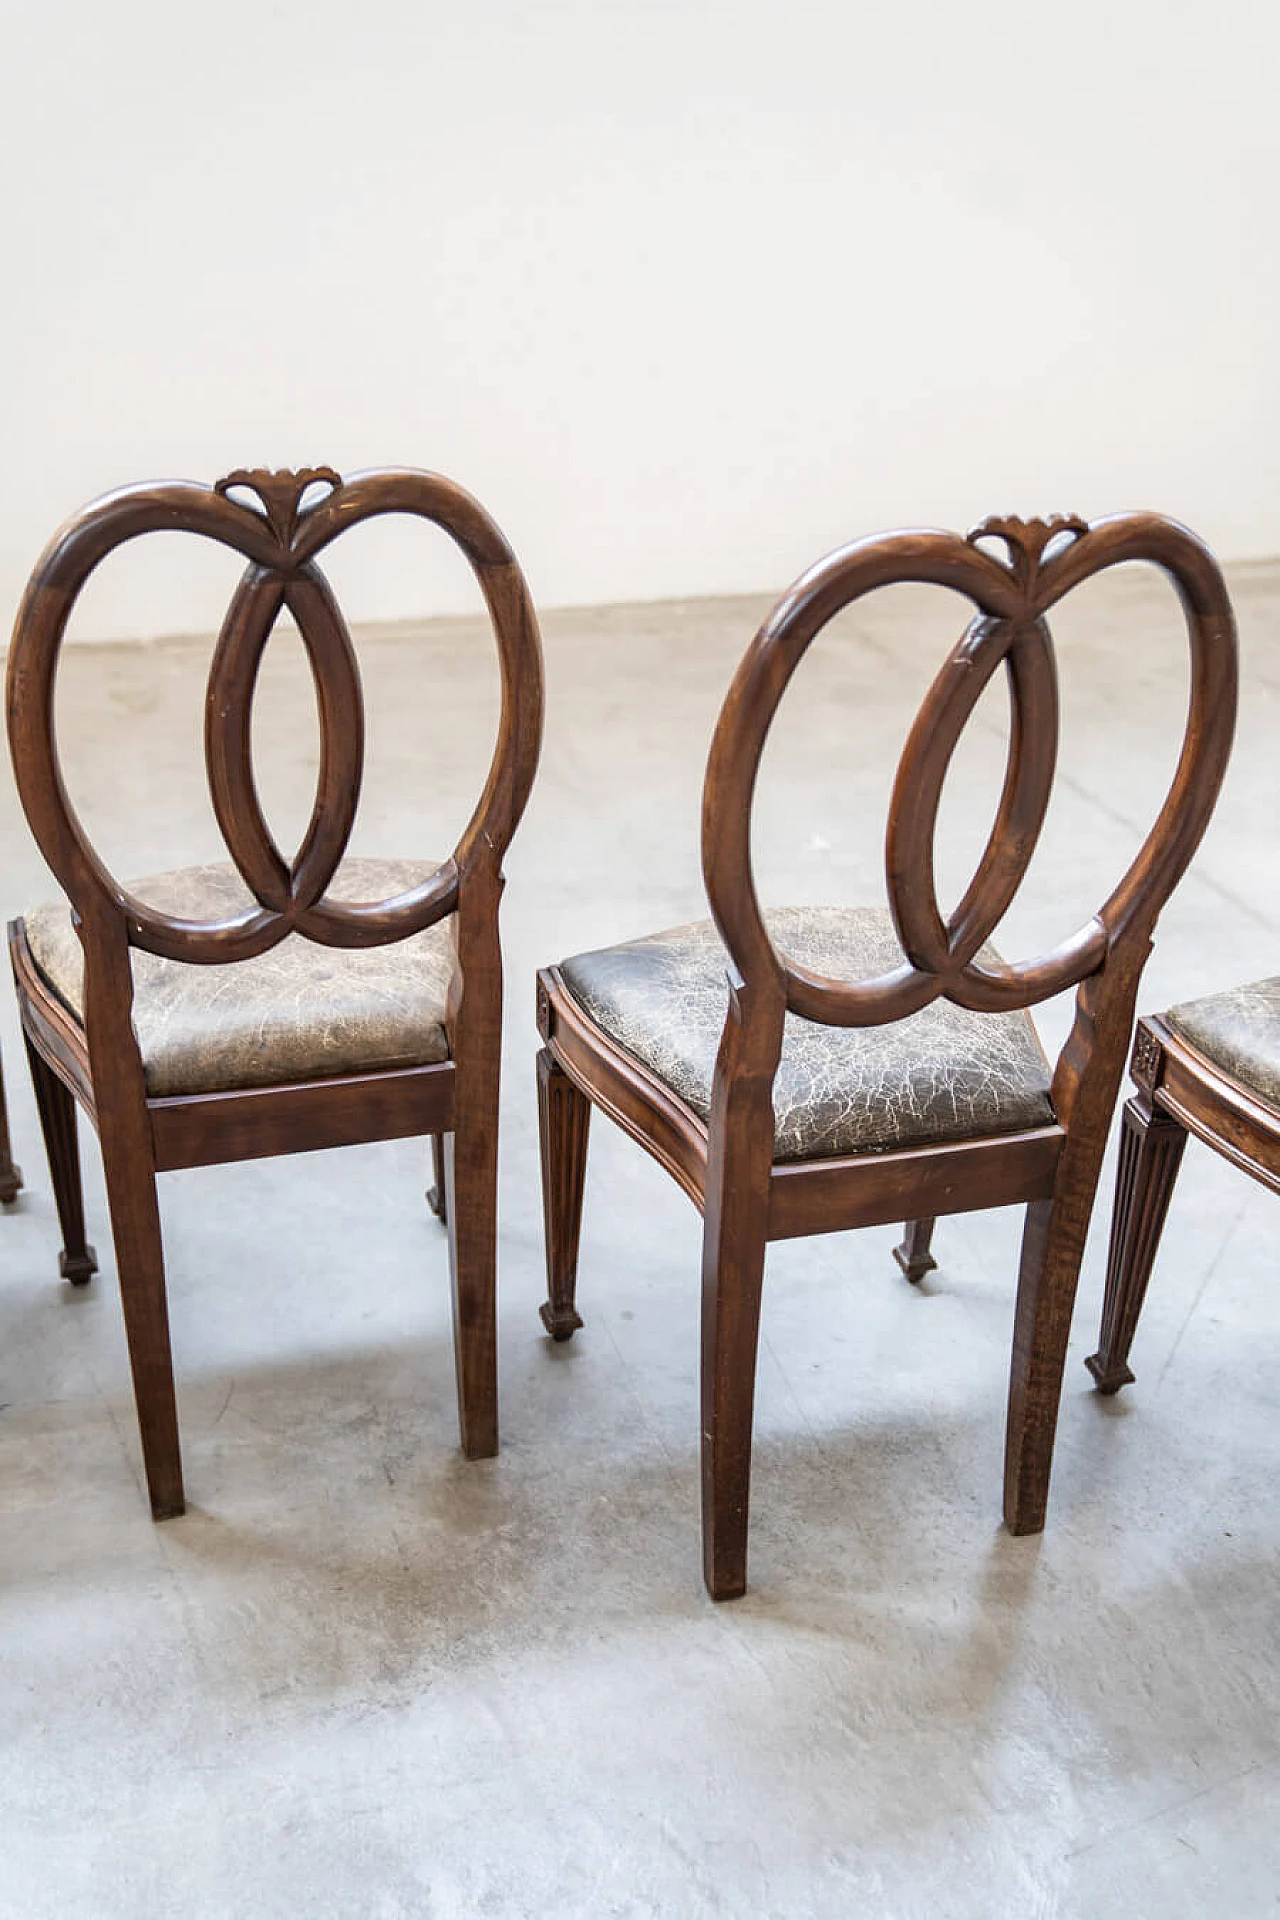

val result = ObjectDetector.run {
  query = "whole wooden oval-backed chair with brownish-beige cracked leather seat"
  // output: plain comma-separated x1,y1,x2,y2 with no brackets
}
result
8,467,543,1519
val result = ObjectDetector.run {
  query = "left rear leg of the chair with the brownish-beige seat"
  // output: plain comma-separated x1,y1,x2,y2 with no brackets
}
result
102,1125,186,1521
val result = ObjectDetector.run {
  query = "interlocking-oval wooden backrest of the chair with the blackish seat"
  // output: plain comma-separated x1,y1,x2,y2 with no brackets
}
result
702,513,1238,1119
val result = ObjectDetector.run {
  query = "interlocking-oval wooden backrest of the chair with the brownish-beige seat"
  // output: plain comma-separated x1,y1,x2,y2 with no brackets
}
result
8,467,543,970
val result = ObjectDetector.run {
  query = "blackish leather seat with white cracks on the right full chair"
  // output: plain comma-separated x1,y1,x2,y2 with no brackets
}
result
560,906,1054,1160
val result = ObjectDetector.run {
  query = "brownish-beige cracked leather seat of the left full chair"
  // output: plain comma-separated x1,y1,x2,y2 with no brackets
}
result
25,860,453,1098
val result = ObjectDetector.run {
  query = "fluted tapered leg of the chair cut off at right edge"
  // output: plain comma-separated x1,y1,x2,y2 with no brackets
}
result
1084,1094,1186,1394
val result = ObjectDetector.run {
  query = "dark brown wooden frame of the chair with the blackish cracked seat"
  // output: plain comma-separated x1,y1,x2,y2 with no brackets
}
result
539,515,1236,1599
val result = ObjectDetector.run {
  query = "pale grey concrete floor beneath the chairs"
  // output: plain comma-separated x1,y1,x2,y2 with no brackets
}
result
0,566,1280,1920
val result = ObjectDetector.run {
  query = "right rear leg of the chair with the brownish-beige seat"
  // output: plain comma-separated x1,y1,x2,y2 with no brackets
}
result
445,1121,497,1459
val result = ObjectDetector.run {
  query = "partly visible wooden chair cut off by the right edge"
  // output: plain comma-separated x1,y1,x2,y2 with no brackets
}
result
1084,977,1280,1394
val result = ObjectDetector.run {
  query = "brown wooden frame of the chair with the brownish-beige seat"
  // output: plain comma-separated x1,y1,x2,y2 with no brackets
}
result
8,467,543,1519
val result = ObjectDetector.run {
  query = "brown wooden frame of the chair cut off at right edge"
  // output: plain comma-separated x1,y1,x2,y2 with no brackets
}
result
1084,1014,1280,1394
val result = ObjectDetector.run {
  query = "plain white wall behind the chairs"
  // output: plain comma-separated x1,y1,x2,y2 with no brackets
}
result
0,0,1280,634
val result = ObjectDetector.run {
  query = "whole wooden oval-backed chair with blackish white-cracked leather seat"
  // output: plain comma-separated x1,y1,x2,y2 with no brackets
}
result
537,515,1236,1599
